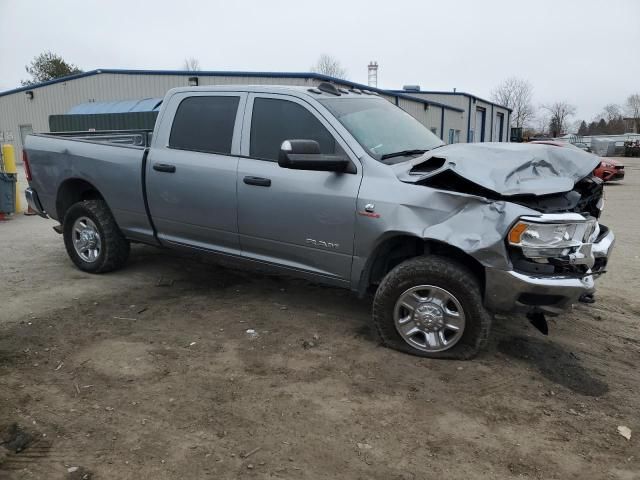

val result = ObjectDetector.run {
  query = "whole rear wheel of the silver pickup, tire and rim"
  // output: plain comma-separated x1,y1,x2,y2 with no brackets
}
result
63,200,129,273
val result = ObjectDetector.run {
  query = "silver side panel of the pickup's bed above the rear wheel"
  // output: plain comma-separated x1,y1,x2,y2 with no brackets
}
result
25,131,153,241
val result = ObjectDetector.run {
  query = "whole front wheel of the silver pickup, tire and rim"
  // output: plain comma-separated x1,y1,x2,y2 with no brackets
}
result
373,256,492,360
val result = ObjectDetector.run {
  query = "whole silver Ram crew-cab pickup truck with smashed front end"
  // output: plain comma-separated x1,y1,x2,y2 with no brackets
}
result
24,84,614,359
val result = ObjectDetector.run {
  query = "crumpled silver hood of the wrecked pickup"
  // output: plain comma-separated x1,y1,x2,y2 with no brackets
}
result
393,143,600,196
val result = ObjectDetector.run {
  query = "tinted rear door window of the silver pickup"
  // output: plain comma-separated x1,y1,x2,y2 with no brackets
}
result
169,96,240,153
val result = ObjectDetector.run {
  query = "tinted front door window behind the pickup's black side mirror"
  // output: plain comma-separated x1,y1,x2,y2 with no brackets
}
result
250,98,342,161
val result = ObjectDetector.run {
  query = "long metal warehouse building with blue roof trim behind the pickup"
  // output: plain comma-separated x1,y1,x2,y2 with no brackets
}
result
0,69,509,155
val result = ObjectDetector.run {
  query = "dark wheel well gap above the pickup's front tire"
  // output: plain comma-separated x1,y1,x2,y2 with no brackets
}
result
360,235,485,294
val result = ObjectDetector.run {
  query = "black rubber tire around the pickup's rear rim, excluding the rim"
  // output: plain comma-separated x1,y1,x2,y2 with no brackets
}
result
62,200,130,273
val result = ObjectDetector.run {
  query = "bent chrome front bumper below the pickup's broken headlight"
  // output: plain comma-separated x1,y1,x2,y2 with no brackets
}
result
484,230,615,314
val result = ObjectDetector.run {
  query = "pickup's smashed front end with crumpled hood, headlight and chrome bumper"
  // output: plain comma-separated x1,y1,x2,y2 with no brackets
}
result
396,144,614,318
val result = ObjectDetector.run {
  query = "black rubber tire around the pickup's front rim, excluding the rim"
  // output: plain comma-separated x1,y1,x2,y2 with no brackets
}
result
373,255,493,360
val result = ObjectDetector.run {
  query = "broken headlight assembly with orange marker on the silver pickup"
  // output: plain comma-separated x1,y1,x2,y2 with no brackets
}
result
507,214,598,261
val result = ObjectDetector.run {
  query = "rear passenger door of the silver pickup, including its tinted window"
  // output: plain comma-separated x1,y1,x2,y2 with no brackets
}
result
146,92,247,255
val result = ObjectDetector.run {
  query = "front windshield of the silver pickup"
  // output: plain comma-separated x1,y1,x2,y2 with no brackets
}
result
319,97,443,160
